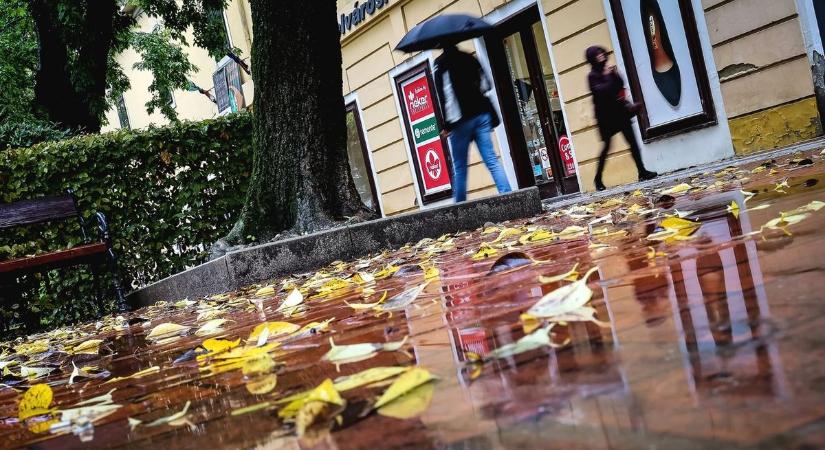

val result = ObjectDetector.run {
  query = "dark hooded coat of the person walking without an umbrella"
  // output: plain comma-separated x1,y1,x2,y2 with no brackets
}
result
586,47,630,140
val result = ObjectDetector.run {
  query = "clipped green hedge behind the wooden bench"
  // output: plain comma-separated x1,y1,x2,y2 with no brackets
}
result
0,113,252,325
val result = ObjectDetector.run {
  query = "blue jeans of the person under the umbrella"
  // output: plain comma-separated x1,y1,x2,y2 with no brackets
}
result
450,113,511,203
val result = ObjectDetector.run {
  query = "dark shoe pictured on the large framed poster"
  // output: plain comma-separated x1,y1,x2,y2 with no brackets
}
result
640,0,682,106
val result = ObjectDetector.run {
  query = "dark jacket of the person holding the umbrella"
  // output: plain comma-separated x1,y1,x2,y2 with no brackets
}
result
433,50,499,131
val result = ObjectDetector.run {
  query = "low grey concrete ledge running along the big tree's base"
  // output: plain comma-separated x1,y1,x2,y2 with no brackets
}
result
126,187,542,307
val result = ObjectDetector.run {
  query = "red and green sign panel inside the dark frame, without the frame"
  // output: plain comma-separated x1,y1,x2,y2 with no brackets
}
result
401,72,452,195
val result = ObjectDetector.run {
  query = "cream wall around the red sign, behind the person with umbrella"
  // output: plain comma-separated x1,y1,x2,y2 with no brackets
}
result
338,0,508,215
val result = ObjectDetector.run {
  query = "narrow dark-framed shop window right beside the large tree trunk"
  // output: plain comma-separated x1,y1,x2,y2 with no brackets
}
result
346,102,381,213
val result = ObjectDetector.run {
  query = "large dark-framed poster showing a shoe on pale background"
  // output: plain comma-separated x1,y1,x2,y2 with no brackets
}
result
612,0,715,139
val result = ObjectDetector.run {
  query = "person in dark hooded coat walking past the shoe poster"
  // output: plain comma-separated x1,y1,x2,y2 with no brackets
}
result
585,45,657,191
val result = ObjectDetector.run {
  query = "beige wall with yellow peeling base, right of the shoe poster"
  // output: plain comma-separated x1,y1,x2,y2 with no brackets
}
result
702,0,822,154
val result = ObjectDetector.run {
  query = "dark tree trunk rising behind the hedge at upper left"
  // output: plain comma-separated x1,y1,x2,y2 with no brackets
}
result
29,0,117,133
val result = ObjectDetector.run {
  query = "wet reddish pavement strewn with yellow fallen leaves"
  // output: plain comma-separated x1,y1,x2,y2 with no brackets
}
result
0,151,825,450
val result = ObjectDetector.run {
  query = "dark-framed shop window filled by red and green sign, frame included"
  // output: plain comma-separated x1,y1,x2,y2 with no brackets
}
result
395,62,453,205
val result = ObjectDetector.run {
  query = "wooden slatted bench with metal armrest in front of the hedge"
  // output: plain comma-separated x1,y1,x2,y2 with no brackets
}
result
0,190,126,324
